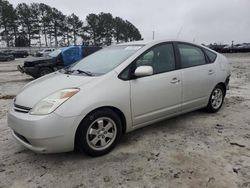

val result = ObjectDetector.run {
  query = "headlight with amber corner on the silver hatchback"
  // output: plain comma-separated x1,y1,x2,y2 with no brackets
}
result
30,88,80,115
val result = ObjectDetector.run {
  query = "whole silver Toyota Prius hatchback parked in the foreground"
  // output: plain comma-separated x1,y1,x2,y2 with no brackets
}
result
8,40,230,156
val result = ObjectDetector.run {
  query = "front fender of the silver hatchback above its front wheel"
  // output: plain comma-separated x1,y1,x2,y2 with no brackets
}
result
55,72,132,133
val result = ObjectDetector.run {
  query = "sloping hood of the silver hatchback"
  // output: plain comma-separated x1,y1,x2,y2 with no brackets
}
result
15,72,97,108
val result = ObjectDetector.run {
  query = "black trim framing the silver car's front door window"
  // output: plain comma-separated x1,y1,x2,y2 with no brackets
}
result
118,41,179,81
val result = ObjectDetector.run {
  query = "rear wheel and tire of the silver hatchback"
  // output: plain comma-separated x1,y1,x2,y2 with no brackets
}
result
206,85,226,113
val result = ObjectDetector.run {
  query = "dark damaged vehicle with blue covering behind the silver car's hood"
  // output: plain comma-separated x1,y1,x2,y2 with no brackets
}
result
17,46,101,78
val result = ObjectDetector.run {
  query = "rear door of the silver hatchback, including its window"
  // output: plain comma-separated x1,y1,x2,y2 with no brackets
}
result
177,43,216,111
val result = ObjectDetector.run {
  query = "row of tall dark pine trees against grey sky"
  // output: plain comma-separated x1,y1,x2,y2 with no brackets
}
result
0,0,142,47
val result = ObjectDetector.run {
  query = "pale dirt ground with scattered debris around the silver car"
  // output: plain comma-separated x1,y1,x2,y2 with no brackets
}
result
0,54,250,188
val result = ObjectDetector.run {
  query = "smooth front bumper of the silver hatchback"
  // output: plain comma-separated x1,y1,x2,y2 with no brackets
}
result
8,105,79,153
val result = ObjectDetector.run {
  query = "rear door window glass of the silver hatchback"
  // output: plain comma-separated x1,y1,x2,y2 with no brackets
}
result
178,44,206,68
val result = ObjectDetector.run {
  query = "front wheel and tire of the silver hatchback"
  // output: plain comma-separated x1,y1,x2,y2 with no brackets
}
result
75,108,122,157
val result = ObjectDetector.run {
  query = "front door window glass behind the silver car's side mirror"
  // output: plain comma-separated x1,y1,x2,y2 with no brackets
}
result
135,43,175,74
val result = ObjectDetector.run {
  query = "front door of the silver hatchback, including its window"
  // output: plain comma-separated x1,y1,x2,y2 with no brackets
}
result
130,43,182,125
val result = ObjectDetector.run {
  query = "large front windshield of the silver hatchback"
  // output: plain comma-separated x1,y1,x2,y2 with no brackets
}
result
68,45,142,75
